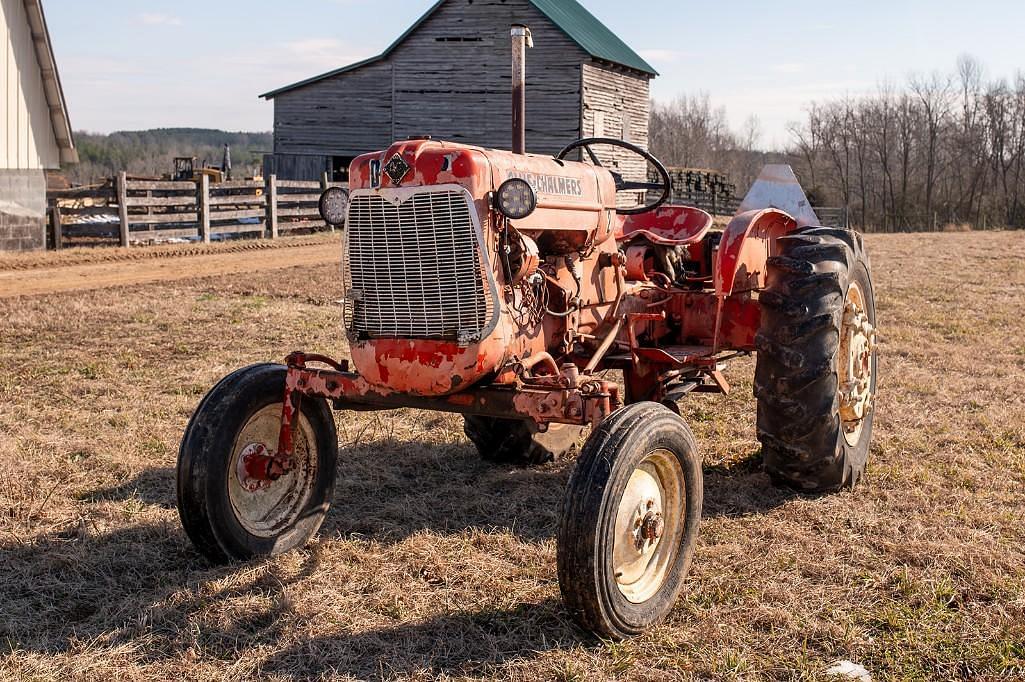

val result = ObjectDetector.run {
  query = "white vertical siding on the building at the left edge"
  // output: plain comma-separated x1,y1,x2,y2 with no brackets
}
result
0,0,60,170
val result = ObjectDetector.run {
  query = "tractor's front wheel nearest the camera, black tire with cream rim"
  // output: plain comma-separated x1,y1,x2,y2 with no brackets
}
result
558,402,703,639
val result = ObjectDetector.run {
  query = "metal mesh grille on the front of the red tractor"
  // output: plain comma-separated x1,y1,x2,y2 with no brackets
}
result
343,189,495,342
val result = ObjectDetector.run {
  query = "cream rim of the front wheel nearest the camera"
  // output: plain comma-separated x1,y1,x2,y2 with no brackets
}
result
612,449,687,604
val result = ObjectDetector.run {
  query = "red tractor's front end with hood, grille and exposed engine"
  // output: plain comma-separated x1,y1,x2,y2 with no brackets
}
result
342,139,619,397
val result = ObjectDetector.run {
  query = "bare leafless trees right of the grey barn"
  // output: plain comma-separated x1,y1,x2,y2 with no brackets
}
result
651,56,1025,232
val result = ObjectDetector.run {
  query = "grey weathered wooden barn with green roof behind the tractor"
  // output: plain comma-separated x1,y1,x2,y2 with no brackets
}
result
262,0,657,182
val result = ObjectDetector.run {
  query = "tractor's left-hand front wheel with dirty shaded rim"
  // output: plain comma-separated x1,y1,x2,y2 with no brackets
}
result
177,364,338,563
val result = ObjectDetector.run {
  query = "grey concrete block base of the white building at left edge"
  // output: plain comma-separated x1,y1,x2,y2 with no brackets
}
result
0,169,46,251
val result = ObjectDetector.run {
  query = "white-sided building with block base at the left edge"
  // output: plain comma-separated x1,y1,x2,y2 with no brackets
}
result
0,0,78,251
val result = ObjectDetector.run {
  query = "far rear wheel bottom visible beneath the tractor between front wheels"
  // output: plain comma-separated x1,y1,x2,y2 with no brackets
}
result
462,414,586,467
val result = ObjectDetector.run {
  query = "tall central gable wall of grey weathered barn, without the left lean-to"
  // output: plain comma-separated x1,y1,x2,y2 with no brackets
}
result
390,0,590,154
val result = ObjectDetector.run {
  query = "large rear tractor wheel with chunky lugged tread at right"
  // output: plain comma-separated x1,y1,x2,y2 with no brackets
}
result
754,228,878,492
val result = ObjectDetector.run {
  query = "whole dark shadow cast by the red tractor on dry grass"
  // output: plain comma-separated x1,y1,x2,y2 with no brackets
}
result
0,439,796,668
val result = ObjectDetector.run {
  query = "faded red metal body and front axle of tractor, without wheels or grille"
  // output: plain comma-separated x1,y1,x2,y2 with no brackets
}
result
262,139,815,457
